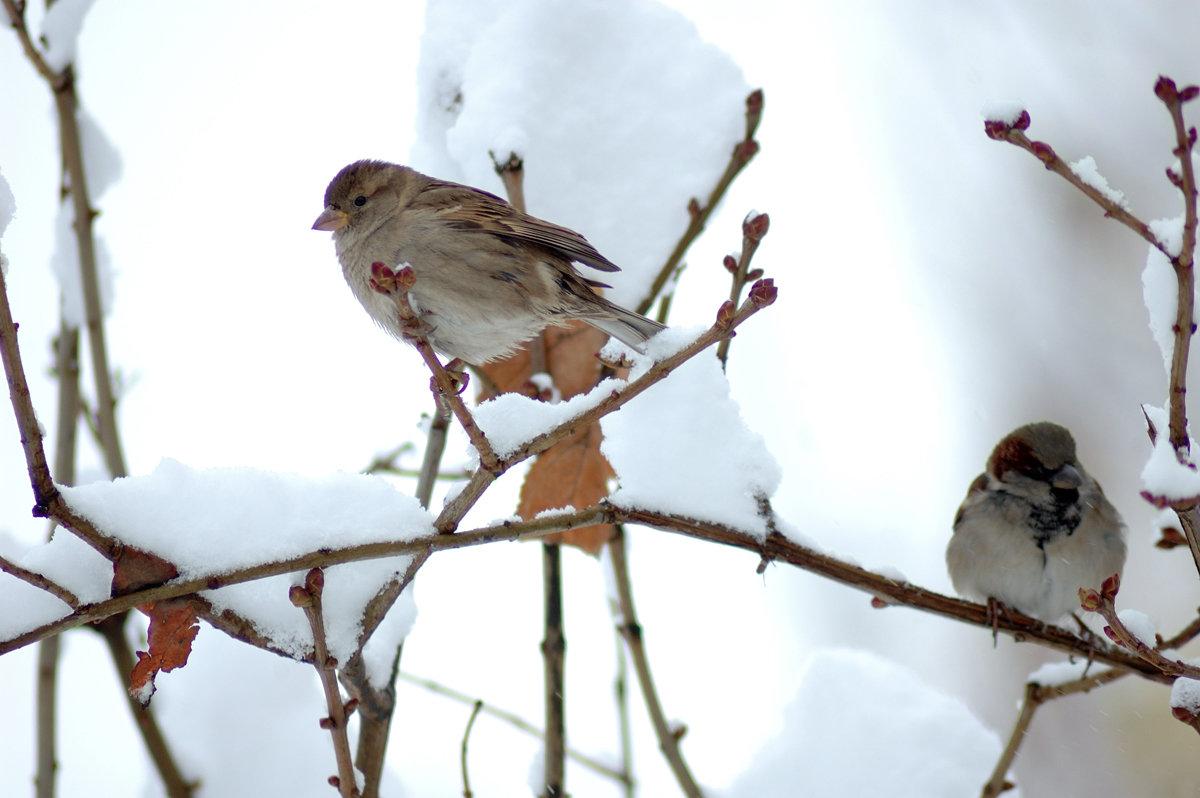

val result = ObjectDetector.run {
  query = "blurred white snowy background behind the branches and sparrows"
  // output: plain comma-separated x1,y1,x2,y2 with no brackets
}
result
0,0,1200,796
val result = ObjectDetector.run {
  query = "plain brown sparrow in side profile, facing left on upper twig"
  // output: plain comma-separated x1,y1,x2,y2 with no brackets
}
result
312,161,662,365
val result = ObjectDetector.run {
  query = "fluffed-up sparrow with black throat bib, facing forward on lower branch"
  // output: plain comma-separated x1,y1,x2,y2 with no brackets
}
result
946,421,1126,623
